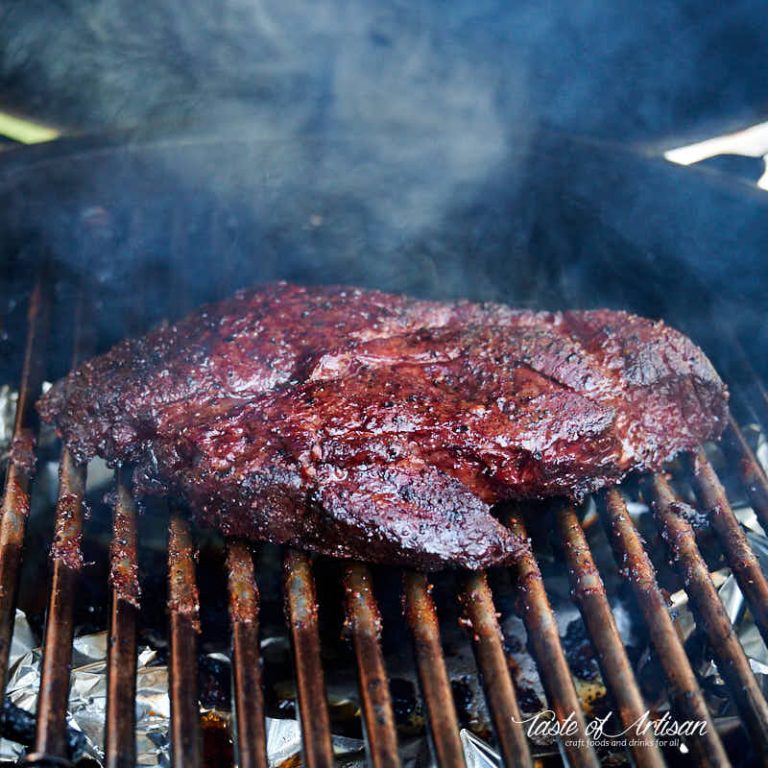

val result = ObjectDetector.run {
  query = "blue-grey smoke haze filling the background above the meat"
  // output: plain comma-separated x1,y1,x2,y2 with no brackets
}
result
0,0,768,378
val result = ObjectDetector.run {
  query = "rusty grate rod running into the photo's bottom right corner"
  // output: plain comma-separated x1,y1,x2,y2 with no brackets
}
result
647,475,768,756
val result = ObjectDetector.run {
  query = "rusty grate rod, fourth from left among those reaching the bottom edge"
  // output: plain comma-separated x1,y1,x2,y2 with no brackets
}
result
227,541,267,768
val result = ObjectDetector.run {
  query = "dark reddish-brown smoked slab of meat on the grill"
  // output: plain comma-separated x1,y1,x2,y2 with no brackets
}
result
40,284,727,568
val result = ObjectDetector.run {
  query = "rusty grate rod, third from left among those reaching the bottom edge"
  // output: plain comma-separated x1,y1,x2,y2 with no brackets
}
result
168,510,202,768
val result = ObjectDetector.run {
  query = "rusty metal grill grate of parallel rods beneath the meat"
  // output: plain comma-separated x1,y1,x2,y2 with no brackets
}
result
0,273,768,768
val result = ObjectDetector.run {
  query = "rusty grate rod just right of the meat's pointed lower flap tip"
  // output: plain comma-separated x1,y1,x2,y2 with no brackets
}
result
505,514,600,768
